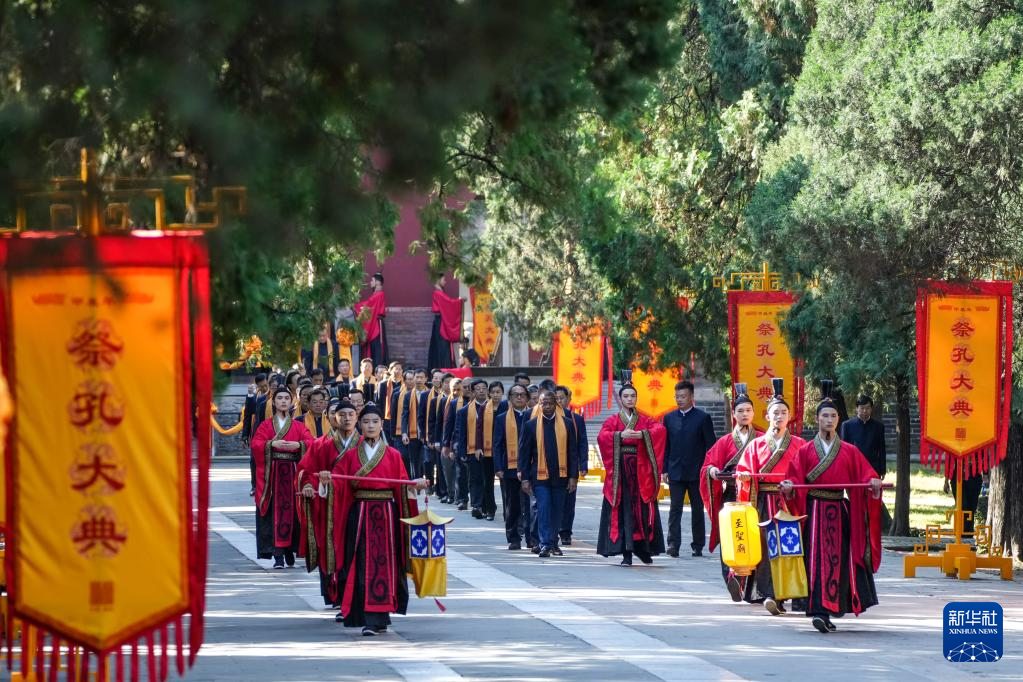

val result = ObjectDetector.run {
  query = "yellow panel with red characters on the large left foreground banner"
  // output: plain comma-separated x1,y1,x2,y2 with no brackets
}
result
10,268,190,648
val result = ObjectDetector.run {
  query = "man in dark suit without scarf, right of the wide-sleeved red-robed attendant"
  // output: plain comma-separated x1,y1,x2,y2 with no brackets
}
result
661,380,717,556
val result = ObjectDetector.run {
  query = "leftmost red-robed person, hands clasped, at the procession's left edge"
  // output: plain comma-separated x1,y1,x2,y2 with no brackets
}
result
252,387,313,569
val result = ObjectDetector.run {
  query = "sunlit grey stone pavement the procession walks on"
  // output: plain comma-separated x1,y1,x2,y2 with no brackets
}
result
188,462,1023,682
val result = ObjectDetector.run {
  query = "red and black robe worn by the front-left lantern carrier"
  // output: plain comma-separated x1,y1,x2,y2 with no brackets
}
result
331,439,418,627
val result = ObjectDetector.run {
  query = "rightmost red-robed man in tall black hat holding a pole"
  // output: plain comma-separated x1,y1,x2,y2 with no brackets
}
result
782,379,881,633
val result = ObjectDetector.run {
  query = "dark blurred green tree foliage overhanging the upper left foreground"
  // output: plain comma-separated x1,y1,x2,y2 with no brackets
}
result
0,0,673,357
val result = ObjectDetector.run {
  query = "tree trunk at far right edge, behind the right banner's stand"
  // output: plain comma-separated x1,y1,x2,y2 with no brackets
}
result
987,423,1023,559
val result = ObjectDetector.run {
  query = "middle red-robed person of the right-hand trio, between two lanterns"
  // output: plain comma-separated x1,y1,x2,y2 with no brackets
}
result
736,378,806,616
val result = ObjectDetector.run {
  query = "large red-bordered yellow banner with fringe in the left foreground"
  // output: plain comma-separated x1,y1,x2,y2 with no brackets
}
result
0,232,213,680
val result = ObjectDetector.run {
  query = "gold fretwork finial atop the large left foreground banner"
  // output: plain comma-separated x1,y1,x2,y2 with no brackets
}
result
0,148,248,236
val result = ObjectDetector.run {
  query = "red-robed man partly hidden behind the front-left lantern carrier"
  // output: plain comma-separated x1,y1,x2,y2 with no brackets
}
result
299,400,359,606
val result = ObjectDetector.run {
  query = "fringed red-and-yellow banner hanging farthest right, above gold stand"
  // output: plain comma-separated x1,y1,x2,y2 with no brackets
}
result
917,281,1013,478
